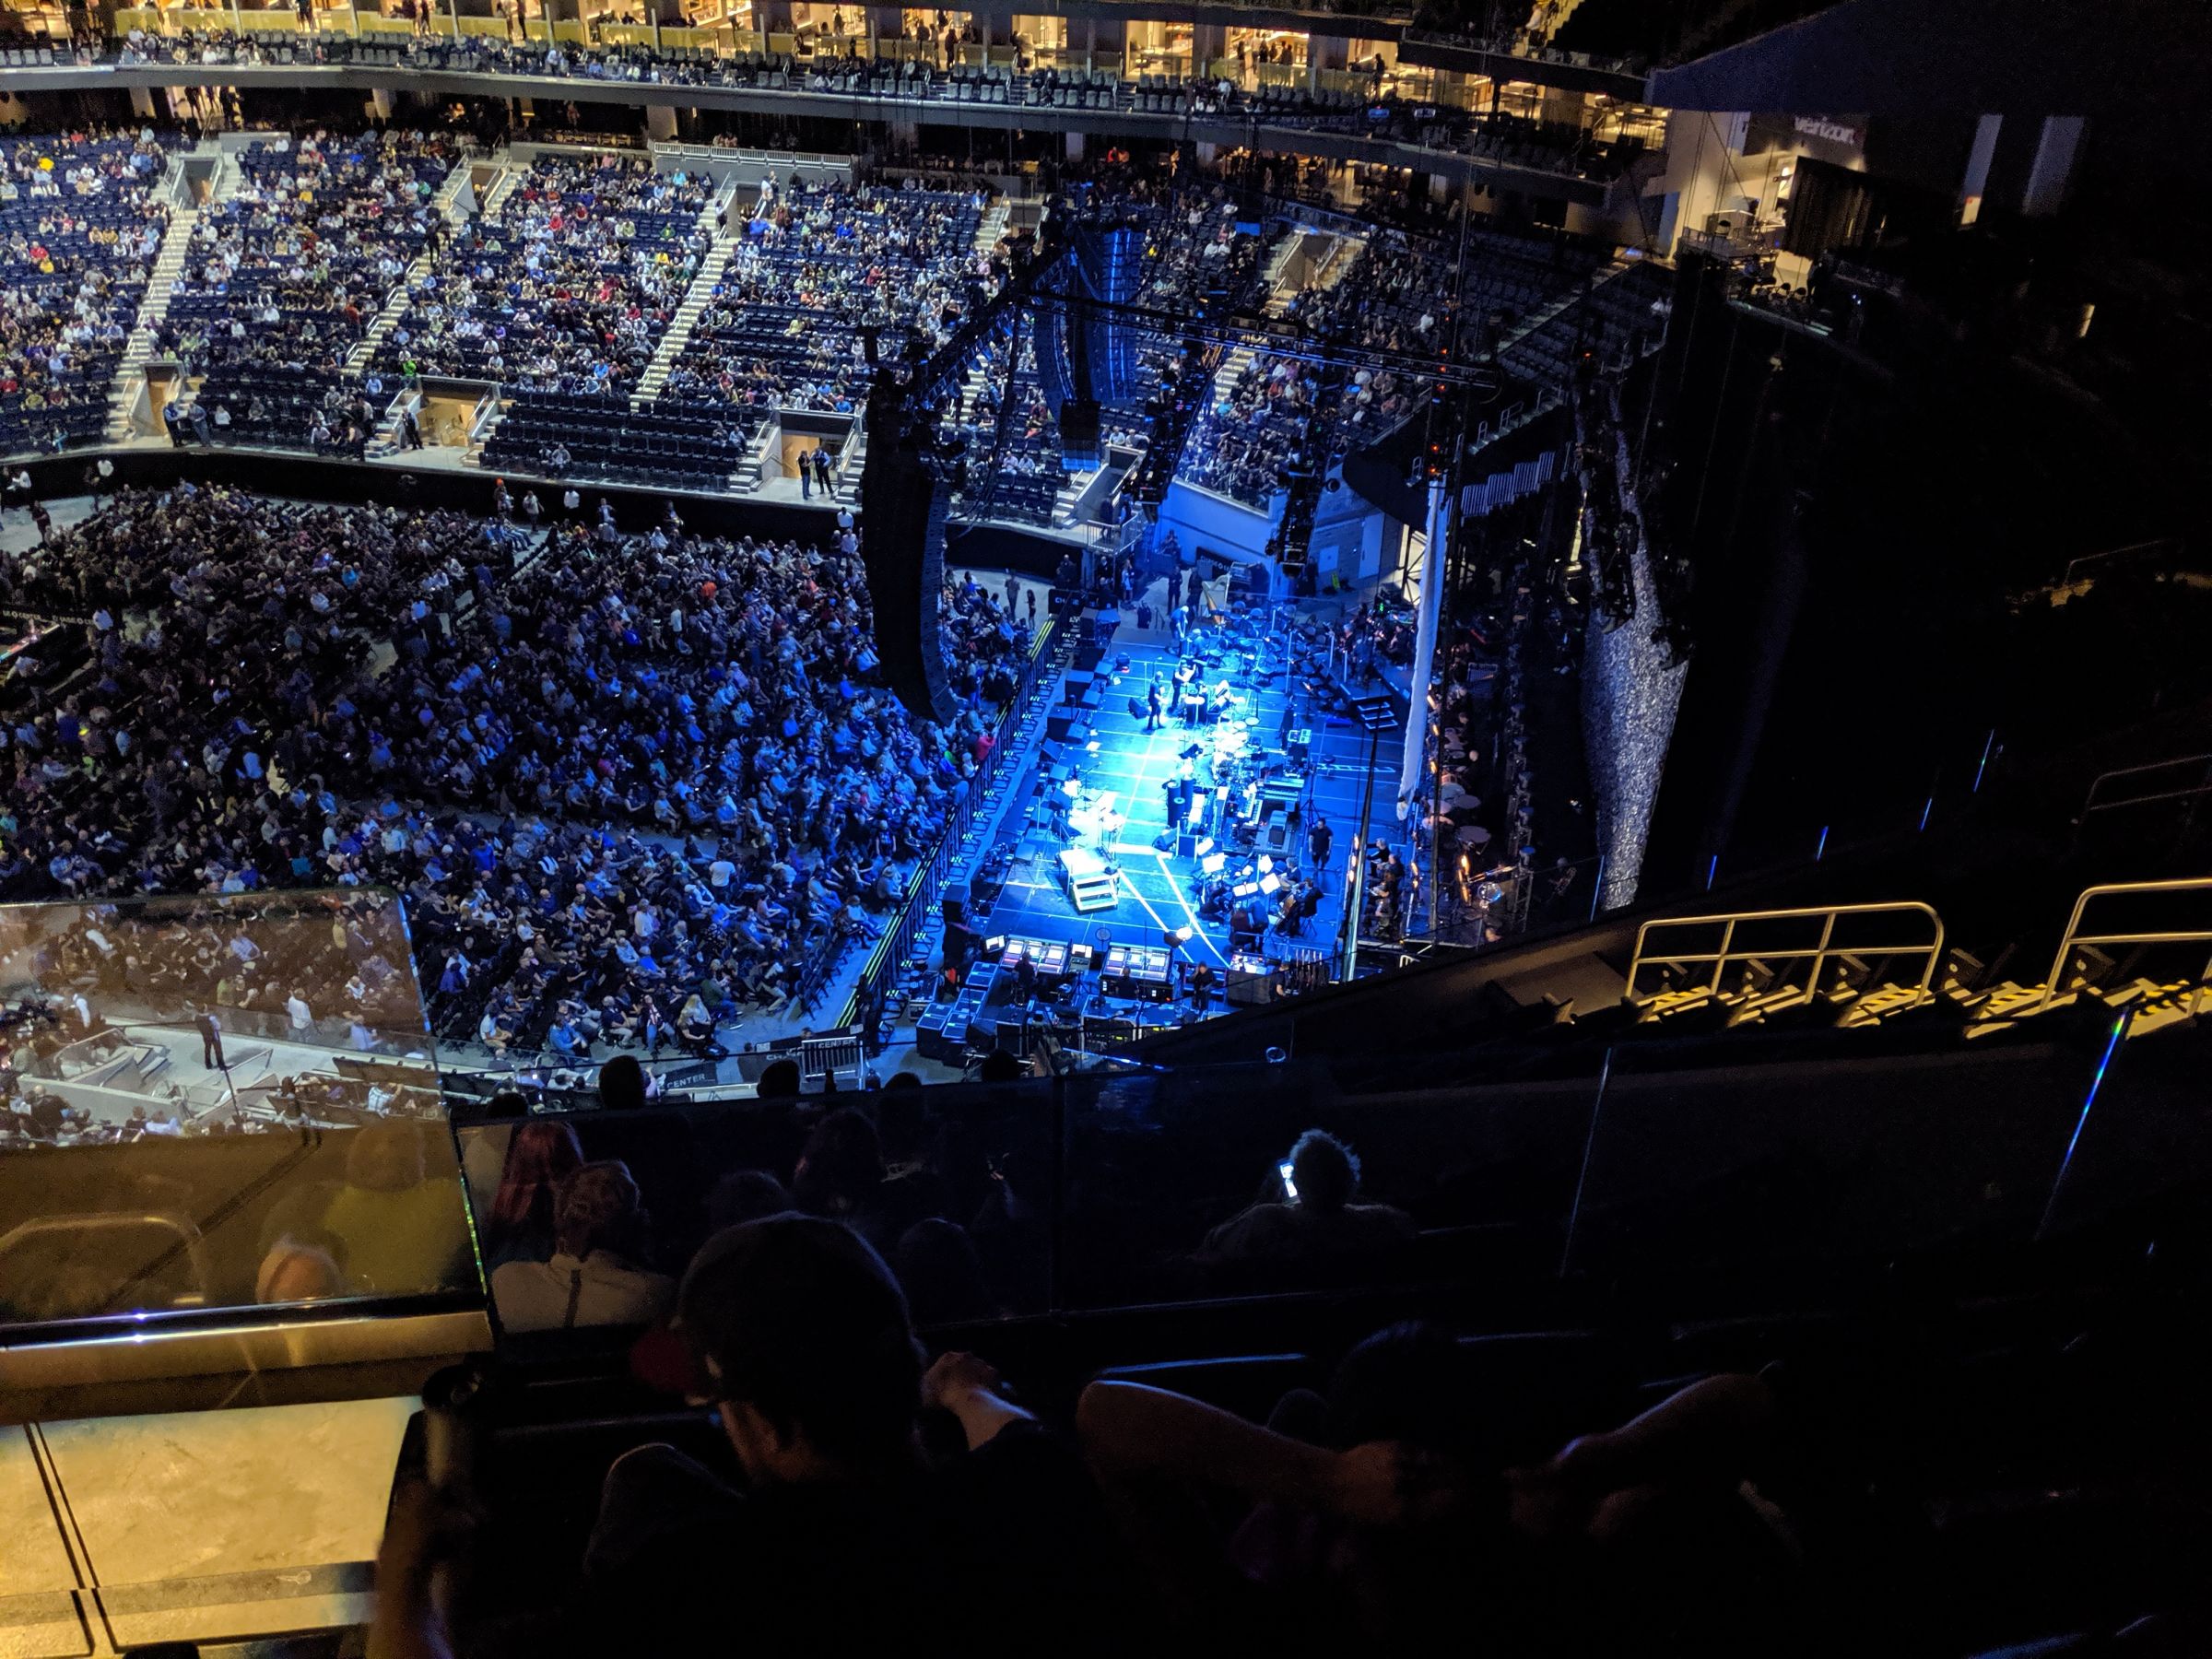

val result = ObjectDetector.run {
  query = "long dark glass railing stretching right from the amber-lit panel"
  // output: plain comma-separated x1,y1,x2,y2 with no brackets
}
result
455,1013,2212,1334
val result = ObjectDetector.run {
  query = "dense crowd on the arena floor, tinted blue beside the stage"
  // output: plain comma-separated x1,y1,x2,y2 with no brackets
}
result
0,485,1030,1070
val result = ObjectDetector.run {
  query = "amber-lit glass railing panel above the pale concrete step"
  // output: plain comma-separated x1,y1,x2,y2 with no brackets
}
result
0,889,480,1327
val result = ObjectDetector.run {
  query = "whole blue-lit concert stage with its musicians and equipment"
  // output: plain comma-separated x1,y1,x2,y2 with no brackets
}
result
918,610,1403,1062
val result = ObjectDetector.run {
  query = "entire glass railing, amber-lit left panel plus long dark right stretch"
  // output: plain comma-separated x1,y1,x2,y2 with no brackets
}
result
0,889,2212,1347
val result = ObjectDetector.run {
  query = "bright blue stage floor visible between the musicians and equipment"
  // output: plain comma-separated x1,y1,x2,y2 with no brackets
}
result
955,619,1400,1022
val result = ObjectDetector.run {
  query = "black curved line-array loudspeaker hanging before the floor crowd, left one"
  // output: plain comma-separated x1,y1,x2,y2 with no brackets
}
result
861,396,953,721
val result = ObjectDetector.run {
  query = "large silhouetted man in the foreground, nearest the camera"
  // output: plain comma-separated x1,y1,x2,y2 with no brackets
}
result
370,1212,1126,1659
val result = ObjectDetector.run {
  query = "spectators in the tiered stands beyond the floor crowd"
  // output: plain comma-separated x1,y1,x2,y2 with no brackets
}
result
0,131,1588,548
